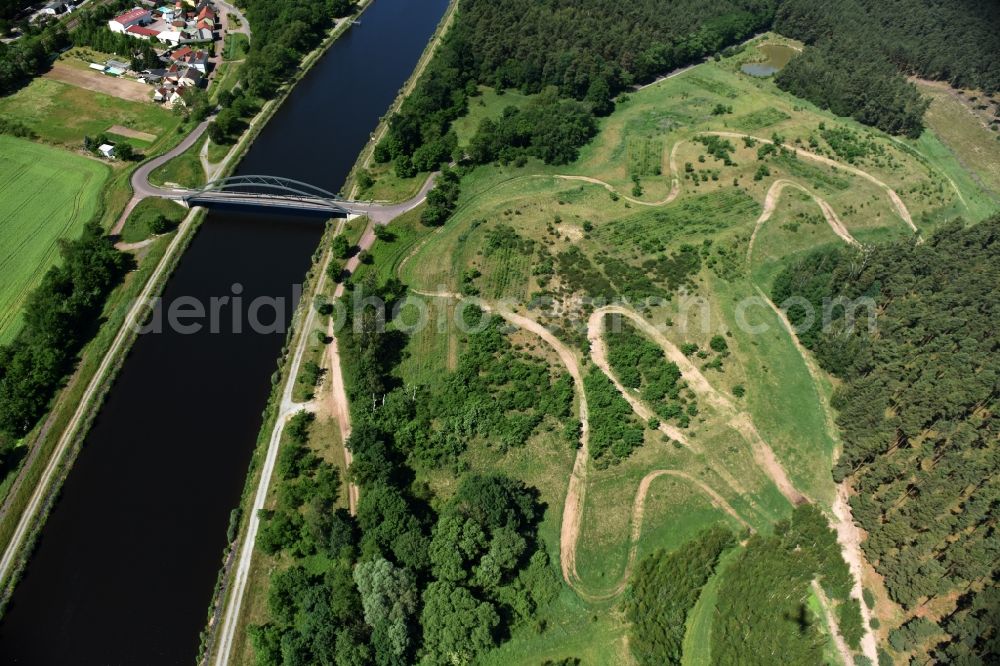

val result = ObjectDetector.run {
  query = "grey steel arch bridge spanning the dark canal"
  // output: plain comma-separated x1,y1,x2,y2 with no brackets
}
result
182,176,351,215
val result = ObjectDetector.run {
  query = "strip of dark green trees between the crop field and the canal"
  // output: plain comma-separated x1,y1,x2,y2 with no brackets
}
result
0,222,133,451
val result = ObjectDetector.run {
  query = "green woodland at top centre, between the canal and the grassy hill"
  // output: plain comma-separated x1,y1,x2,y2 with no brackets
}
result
375,0,774,182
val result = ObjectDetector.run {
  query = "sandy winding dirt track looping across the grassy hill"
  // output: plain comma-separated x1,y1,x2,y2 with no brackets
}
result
404,132,919,652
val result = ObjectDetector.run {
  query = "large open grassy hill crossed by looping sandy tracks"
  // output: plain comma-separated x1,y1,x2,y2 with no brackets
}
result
373,36,1000,664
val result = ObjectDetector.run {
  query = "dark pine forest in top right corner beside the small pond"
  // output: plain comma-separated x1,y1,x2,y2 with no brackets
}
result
774,0,1000,137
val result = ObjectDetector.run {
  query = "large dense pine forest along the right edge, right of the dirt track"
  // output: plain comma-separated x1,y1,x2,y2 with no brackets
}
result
773,217,1000,664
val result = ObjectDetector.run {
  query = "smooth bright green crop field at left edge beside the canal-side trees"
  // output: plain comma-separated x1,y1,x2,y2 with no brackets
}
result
0,136,110,342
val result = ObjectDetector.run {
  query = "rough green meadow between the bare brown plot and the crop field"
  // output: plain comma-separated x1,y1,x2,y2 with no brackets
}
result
0,77,181,150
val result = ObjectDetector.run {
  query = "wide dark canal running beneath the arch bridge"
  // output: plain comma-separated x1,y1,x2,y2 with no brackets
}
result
0,0,448,666
